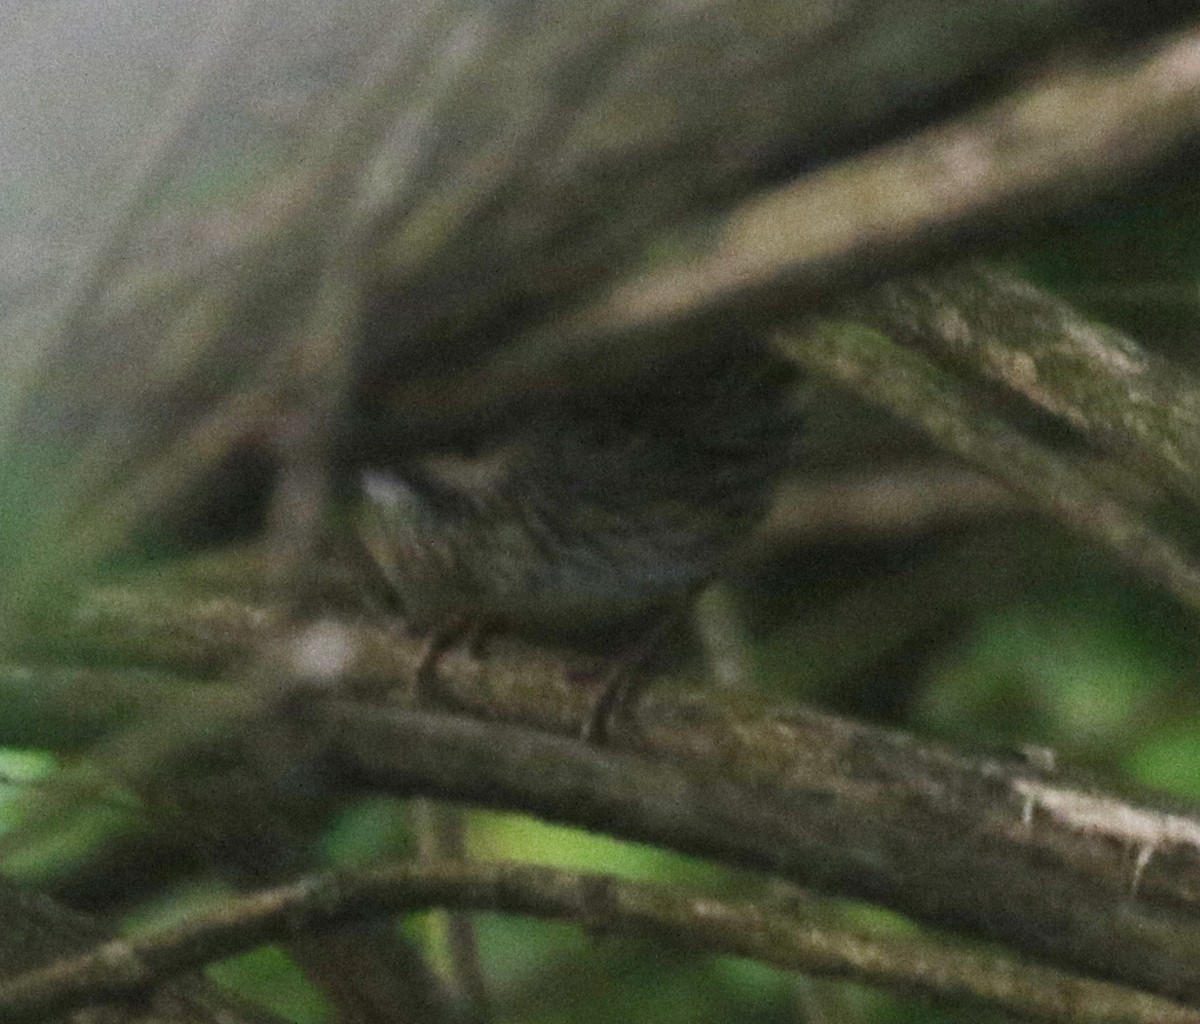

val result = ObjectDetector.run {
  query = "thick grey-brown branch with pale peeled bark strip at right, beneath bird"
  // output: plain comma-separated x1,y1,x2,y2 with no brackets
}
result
307,700,1200,1004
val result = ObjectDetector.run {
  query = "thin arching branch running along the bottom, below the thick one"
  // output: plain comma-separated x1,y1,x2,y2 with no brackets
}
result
0,864,1200,1024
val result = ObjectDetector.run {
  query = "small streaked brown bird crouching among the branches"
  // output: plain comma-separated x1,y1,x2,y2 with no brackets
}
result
361,345,799,733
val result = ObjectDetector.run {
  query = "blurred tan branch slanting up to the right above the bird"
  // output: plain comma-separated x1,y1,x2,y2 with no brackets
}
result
384,22,1200,432
